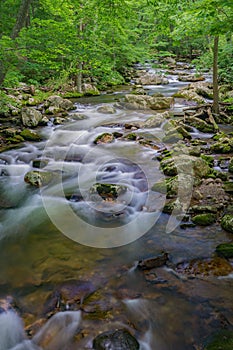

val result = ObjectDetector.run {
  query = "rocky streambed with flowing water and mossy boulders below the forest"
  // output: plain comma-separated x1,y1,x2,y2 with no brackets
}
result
0,62,233,350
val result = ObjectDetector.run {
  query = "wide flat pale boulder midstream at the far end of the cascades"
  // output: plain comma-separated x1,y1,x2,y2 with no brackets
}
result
125,94,173,110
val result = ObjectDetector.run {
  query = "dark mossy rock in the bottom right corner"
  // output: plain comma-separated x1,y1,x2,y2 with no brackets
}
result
204,330,233,350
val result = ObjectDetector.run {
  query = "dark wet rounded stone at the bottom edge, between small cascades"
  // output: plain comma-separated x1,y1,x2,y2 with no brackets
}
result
93,329,139,350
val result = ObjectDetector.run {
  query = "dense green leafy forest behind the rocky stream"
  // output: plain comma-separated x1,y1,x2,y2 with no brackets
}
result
0,0,233,92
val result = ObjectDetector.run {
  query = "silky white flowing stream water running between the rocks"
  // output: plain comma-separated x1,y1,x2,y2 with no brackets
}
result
0,64,233,350
